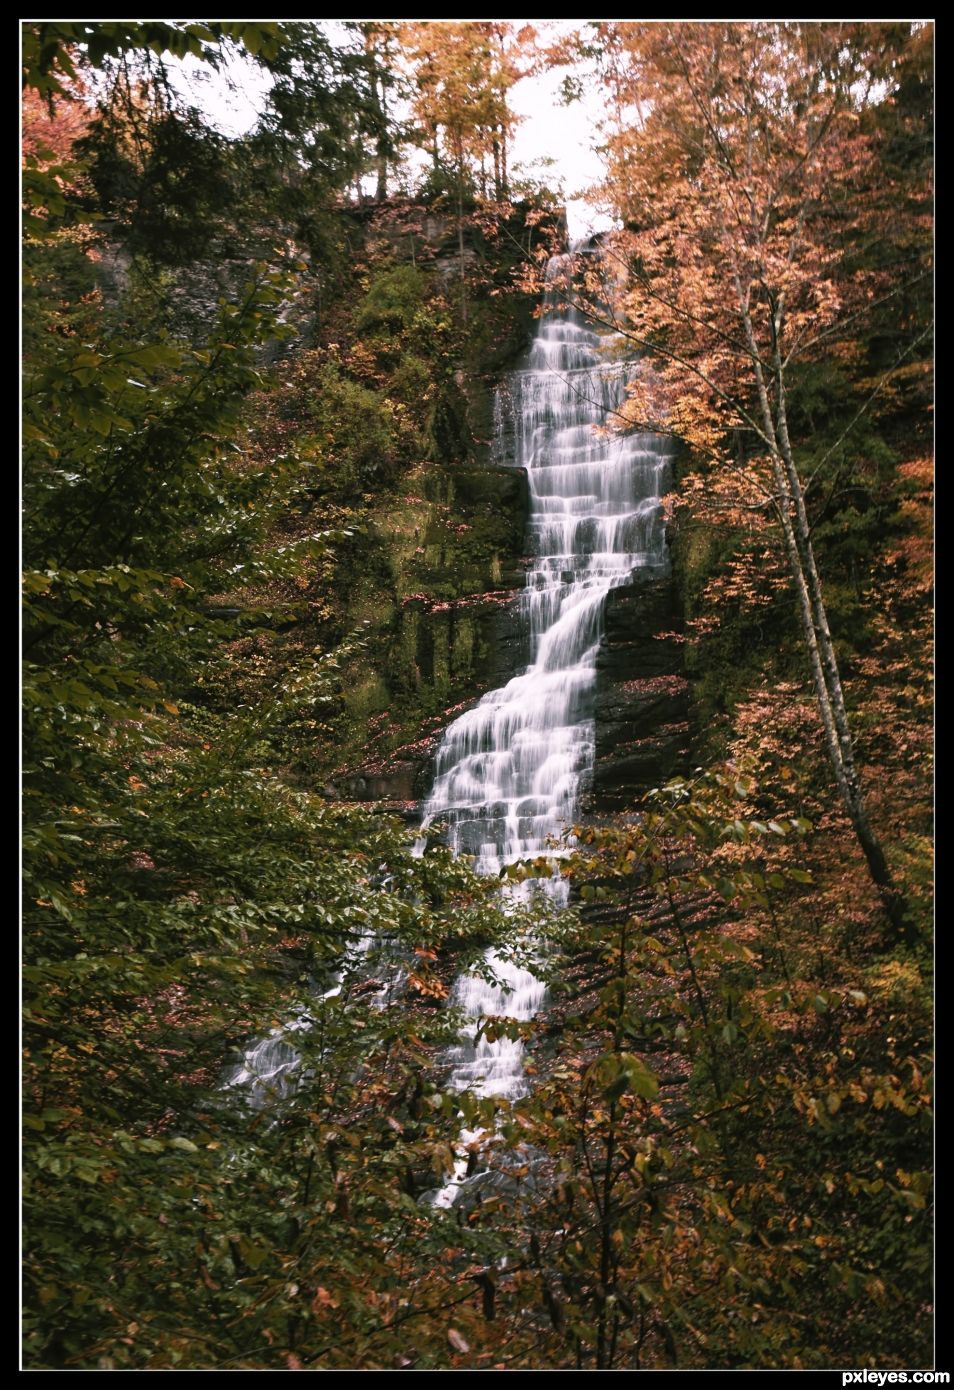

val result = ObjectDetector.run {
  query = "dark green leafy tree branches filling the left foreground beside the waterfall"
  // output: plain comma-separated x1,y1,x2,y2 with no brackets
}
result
22,26,514,1368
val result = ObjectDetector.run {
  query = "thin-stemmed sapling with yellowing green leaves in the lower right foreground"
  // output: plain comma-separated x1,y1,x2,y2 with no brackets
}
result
478,772,932,1369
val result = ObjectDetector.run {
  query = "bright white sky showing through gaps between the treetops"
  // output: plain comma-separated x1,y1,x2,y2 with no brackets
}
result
170,19,612,239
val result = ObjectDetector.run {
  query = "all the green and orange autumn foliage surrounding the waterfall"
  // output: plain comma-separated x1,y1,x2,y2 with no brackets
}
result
22,21,933,1371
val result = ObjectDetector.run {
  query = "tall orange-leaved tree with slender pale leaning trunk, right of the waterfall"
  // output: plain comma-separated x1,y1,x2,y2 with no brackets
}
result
567,22,928,933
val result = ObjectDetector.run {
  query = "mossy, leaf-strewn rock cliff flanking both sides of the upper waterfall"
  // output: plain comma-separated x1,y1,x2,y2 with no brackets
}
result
230,206,688,819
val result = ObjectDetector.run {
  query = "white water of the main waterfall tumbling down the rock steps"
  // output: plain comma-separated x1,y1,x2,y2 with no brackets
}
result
424,256,672,1207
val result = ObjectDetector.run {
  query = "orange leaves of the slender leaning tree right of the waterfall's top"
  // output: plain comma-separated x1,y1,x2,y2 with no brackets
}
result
601,21,928,472
